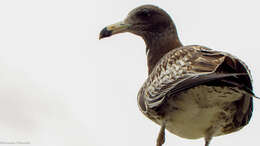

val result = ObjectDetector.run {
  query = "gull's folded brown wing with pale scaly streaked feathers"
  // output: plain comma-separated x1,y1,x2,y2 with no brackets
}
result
138,46,253,111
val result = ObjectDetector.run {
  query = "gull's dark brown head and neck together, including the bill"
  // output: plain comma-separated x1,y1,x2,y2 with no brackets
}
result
99,5,182,73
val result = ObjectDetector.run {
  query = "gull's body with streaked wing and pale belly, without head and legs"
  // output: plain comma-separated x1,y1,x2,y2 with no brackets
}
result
138,46,252,139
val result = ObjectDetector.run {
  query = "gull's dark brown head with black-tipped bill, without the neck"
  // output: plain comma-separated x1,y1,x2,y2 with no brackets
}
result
99,5,176,39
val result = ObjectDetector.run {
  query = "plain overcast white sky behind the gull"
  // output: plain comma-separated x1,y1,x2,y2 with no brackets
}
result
0,0,260,146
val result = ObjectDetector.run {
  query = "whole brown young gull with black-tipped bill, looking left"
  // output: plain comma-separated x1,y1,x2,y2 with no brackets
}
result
99,4,256,146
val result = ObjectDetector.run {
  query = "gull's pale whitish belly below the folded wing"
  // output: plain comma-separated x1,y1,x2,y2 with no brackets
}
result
160,86,242,139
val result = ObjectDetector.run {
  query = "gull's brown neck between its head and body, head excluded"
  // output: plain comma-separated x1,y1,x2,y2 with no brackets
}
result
143,29,182,74
